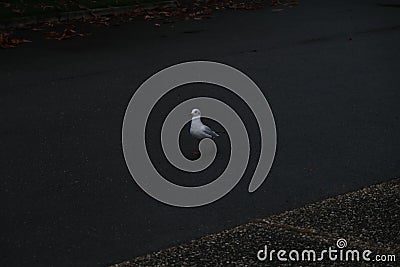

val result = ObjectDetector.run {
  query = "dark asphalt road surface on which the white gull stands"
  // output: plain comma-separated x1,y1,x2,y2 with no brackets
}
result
0,0,400,266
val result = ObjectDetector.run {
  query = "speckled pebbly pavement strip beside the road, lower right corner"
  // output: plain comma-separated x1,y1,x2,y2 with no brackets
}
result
114,179,400,267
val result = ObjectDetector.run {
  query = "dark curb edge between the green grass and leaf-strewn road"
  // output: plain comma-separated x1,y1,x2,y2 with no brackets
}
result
0,1,177,30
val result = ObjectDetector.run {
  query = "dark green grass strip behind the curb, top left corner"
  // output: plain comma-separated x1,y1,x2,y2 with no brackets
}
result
0,0,166,20
